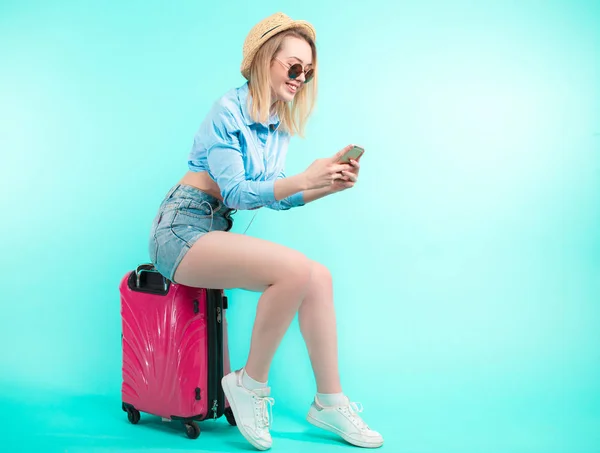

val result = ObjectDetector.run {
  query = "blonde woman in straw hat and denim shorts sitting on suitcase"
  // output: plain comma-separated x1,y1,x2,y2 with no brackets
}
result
150,13,383,450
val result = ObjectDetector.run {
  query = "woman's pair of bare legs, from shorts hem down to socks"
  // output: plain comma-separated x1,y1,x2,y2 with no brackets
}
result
175,232,341,393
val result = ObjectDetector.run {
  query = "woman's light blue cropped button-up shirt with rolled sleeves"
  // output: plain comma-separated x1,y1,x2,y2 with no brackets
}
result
188,83,304,210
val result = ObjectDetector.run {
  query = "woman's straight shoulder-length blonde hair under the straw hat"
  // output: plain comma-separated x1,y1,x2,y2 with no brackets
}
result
248,28,318,137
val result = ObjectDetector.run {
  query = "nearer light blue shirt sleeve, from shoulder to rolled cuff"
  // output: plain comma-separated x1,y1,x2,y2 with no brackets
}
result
202,111,276,210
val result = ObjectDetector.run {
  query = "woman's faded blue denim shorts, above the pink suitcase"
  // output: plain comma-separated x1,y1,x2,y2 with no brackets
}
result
148,184,235,281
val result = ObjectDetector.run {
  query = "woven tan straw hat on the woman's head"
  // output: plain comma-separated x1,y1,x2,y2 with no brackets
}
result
241,13,317,80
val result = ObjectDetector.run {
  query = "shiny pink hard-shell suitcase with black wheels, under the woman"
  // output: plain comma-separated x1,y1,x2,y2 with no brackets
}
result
119,264,235,439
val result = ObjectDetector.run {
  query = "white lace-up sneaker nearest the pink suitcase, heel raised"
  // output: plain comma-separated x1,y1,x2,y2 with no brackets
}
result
221,370,275,450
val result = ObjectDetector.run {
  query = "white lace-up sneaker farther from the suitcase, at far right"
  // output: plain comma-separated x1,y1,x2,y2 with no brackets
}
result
306,396,383,448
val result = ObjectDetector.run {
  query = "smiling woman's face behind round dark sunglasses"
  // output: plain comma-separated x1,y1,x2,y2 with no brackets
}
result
271,36,312,102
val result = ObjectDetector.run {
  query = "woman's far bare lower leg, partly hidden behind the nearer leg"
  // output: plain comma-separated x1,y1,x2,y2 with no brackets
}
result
298,262,342,393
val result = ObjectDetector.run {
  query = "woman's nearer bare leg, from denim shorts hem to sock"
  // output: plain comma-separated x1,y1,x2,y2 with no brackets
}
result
174,231,311,382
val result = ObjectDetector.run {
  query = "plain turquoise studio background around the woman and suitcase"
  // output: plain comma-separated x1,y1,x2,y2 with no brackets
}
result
0,0,600,453
